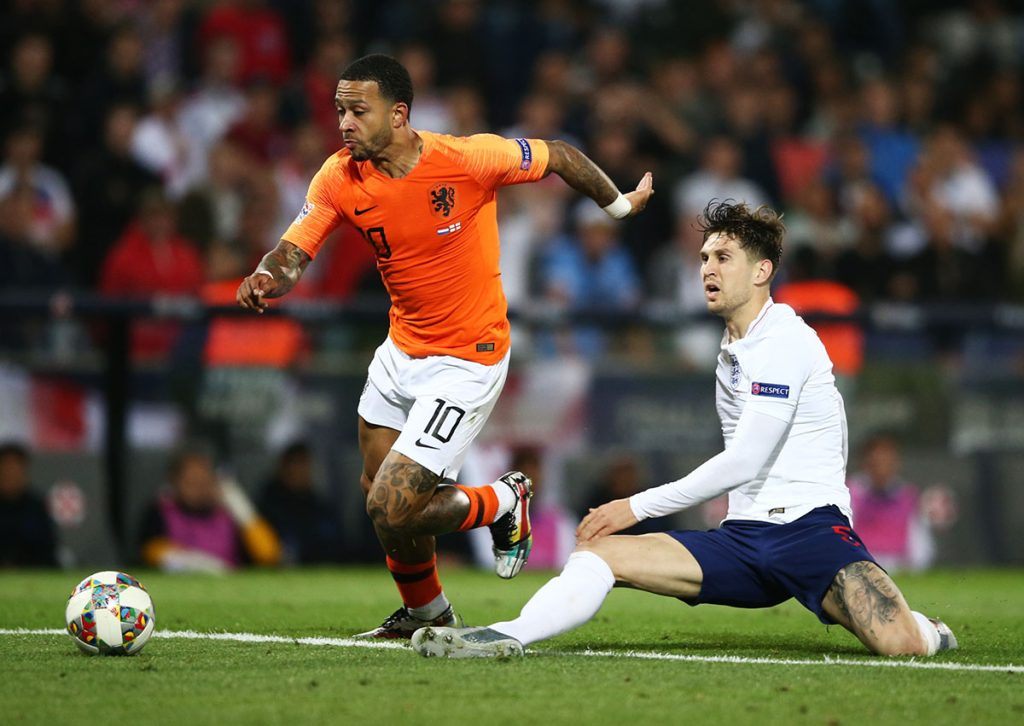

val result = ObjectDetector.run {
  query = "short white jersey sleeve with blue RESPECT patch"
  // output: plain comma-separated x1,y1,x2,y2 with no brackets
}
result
743,335,817,422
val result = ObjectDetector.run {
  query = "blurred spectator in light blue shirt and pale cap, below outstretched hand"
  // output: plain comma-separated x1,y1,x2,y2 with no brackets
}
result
539,201,641,357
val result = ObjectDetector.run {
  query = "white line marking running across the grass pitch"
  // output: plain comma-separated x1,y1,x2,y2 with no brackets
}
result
0,628,1024,673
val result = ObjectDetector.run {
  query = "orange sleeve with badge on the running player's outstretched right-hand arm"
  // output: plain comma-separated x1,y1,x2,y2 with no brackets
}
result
462,133,548,188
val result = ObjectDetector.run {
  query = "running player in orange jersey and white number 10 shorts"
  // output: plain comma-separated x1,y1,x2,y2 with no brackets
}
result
238,54,653,638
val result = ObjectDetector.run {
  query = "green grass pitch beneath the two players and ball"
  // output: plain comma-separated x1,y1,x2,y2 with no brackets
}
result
0,567,1024,726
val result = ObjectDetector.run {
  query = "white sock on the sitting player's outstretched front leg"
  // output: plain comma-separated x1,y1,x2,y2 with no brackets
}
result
490,552,615,645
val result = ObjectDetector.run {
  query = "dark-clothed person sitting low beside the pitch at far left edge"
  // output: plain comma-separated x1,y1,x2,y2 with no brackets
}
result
0,441,57,570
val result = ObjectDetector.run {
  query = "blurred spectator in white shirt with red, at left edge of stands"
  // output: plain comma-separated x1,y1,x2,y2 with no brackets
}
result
0,124,76,260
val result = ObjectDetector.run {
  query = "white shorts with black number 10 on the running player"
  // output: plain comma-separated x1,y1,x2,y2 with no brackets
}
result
358,338,509,479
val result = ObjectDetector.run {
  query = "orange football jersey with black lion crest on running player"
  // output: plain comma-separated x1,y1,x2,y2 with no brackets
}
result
283,131,548,366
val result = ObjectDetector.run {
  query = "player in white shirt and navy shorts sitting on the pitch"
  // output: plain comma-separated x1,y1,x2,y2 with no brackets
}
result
413,202,956,657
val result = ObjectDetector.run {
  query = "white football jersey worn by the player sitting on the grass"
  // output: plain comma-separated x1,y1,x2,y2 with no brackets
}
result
716,299,851,523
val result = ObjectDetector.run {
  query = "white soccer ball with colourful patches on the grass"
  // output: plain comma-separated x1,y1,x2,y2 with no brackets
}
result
65,570,157,655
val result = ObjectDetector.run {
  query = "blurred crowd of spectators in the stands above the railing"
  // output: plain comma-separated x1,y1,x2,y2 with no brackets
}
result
0,0,1024,333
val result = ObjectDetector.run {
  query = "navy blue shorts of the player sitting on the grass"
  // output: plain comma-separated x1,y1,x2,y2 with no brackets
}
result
666,505,874,625
